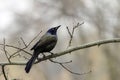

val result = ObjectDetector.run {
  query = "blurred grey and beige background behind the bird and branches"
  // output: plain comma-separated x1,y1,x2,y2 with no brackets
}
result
0,0,120,80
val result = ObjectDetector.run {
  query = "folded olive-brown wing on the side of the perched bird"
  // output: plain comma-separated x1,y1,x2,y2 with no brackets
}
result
31,34,57,50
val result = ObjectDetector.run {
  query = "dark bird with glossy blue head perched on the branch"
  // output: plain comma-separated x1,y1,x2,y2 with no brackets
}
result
25,25,61,73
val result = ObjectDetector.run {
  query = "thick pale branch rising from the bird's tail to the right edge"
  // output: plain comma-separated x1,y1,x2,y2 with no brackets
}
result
35,38,120,64
